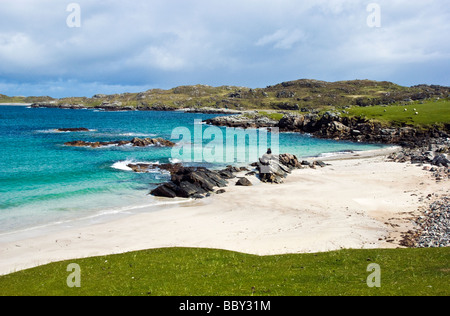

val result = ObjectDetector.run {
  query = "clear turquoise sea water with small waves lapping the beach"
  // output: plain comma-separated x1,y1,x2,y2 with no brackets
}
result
0,106,386,234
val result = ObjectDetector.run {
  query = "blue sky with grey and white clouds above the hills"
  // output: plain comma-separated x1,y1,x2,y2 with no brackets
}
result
0,0,450,97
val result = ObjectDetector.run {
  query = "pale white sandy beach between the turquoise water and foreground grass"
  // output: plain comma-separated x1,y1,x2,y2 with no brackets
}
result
0,148,449,275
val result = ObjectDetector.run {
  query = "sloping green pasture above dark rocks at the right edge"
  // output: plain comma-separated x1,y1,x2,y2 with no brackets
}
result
348,99,450,127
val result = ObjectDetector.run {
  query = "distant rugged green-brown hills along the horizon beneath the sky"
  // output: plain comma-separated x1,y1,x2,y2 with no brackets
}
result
0,79,450,112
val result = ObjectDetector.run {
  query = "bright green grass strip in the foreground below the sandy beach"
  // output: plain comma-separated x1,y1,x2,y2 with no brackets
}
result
0,248,450,296
